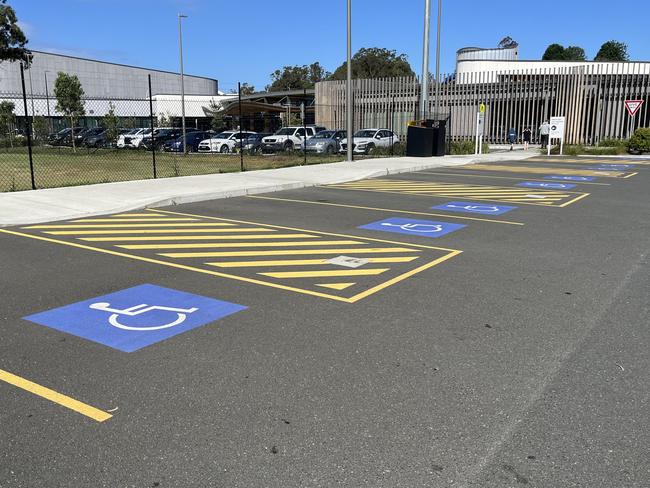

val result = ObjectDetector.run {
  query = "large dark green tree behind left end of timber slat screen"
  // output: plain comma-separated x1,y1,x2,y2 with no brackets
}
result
329,47,415,80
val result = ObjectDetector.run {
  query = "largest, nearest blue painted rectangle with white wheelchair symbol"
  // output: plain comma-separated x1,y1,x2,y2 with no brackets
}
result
24,284,247,352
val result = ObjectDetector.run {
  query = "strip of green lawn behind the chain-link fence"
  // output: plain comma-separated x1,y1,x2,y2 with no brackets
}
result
0,147,345,192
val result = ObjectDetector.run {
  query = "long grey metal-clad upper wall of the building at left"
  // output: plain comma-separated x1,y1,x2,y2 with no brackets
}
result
0,51,218,100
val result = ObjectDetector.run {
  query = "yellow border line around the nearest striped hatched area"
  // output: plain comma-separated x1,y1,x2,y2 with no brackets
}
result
0,227,450,303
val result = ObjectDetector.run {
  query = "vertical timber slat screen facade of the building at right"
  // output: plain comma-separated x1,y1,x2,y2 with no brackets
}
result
316,63,650,144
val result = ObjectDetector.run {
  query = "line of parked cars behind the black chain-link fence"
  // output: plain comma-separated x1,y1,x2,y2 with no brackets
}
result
43,126,399,154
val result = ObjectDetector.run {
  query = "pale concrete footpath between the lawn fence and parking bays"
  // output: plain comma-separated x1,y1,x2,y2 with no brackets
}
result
0,151,539,227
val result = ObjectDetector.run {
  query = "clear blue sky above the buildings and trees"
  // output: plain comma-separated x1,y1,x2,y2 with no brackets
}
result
8,0,650,91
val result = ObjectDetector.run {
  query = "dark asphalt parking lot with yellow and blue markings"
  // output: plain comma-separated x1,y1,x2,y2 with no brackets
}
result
0,156,650,488
